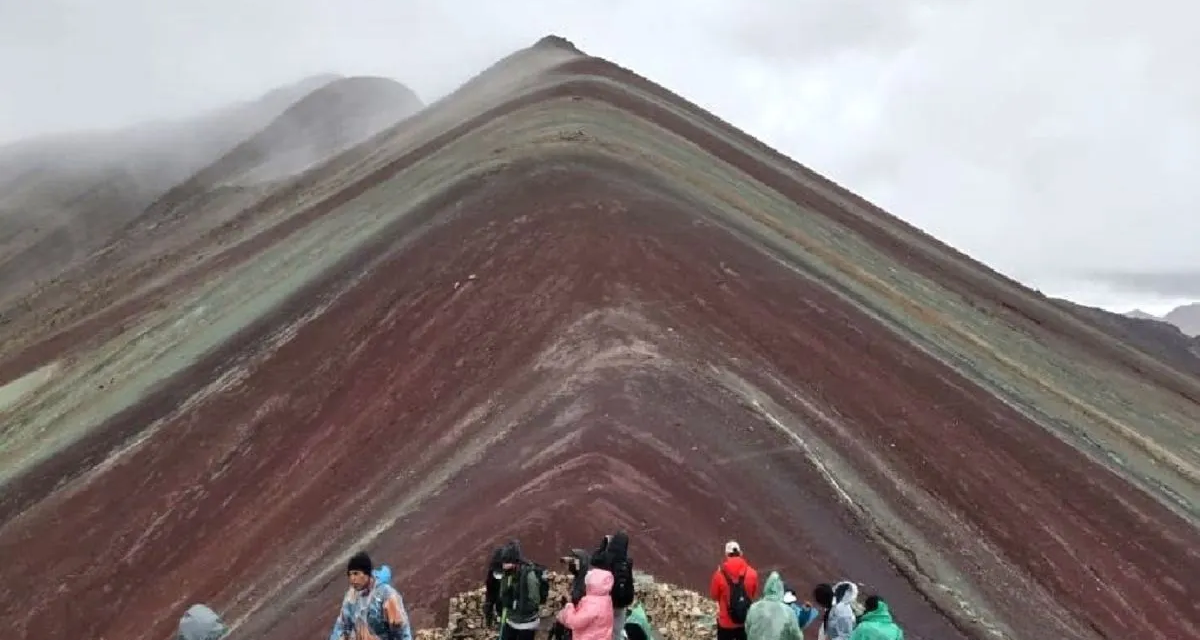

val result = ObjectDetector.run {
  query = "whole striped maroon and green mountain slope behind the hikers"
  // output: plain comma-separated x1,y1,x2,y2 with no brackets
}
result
0,38,1200,640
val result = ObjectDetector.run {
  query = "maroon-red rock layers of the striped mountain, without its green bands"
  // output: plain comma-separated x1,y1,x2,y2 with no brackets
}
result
0,41,1200,640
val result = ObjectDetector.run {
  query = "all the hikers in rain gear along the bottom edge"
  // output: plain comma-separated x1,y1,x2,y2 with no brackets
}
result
171,532,904,640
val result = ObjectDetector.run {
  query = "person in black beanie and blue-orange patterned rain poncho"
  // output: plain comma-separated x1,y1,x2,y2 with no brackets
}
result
329,551,413,640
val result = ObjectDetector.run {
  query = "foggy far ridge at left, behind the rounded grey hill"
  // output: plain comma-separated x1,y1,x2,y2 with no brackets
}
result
0,74,338,300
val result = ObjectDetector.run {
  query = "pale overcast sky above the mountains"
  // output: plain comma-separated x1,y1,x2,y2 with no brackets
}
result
0,0,1200,311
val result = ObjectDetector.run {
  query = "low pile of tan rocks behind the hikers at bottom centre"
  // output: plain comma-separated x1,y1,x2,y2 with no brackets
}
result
416,572,716,640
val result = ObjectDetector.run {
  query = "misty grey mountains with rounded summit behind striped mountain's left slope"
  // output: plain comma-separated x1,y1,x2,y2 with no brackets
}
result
0,74,421,301
